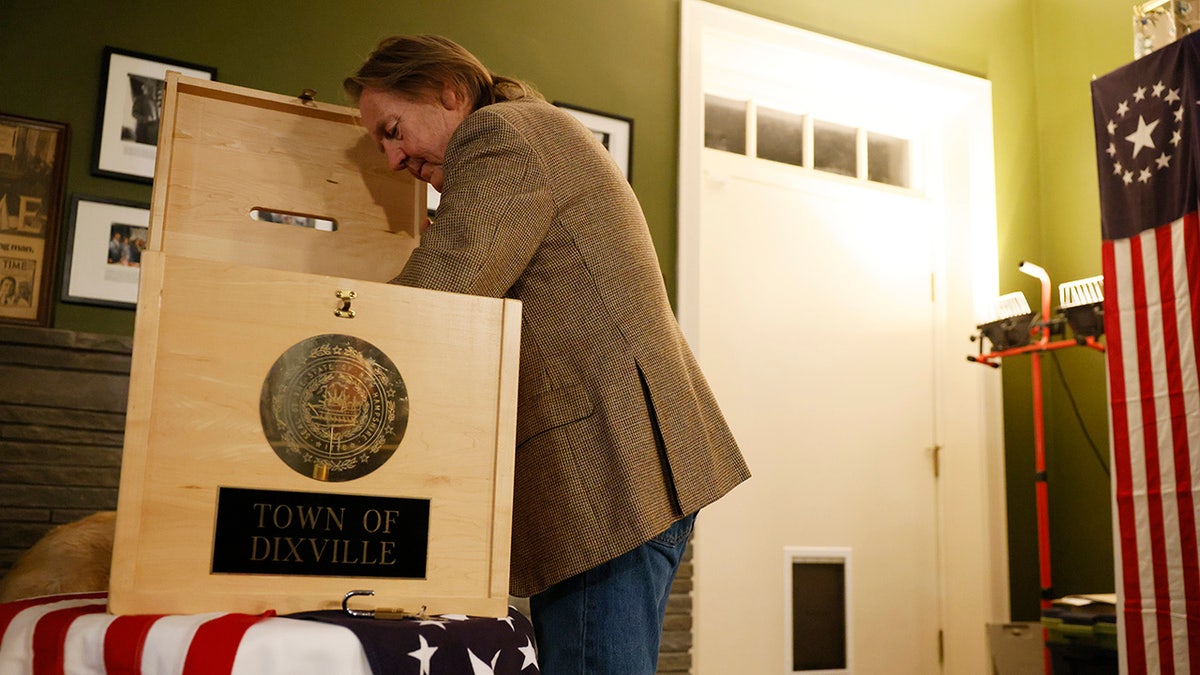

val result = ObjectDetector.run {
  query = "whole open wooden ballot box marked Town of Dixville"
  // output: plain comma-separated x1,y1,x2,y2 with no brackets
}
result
108,73,521,616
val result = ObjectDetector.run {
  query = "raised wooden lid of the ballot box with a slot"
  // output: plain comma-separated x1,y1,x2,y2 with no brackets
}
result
149,73,426,281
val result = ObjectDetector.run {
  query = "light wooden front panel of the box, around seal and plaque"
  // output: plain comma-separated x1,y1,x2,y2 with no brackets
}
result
109,253,520,616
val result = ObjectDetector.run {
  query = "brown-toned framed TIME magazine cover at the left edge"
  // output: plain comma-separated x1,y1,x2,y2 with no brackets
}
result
0,114,70,325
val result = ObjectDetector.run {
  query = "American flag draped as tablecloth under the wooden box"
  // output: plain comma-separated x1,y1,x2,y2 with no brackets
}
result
0,593,539,675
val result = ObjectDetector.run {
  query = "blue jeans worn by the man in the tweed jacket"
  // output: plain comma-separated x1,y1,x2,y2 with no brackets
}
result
529,514,696,675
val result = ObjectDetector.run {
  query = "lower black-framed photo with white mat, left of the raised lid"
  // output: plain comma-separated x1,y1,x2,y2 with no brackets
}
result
62,195,150,310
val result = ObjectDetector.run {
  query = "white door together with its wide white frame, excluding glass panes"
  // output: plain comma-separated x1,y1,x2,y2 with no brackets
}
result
678,0,1008,675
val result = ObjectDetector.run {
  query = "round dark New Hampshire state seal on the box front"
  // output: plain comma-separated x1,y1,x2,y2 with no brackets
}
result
259,334,408,482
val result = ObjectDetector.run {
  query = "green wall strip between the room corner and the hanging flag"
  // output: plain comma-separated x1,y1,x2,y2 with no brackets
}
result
1022,0,1134,614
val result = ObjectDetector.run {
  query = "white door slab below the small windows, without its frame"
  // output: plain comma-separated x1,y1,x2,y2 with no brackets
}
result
697,158,938,675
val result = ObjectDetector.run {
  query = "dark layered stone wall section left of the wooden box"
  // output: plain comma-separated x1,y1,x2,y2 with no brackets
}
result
0,325,132,575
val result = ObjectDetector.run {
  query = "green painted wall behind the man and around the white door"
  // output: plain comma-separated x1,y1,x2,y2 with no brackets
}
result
0,0,1132,619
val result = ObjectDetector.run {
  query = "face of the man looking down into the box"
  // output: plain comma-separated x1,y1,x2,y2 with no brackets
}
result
359,88,469,192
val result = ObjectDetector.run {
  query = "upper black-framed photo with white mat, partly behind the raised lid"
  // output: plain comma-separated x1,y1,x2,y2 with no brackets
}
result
91,47,217,183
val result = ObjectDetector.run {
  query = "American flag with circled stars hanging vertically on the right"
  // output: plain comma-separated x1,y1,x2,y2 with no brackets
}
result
1092,27,1200,675
